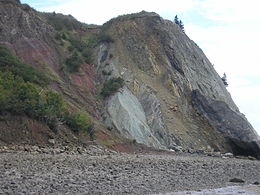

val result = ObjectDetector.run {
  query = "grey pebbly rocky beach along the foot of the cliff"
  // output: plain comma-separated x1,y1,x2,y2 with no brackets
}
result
0,145,260,194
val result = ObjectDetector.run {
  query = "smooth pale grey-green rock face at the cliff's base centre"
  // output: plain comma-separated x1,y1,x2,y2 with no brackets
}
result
106,87,165,148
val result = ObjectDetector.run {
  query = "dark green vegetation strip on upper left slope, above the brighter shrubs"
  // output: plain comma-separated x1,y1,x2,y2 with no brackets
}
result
0,45,48,86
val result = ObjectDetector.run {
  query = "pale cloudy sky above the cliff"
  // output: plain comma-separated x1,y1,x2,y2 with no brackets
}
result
21,0,260,134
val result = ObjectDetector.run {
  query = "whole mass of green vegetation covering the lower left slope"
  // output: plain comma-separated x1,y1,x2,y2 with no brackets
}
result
0,46,94,137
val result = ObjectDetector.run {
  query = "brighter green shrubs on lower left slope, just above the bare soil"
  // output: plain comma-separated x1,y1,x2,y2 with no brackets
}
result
0,72,94,137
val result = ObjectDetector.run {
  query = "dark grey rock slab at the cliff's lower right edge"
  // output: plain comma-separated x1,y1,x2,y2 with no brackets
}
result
191,90,260,157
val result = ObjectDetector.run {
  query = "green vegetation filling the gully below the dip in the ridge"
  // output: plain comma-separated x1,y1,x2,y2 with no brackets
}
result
45,12,113,73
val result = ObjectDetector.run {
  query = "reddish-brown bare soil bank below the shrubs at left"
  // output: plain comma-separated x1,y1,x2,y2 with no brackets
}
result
0,116,84,145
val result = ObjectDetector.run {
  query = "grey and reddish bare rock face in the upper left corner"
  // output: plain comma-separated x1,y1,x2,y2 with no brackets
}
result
0,1,60,69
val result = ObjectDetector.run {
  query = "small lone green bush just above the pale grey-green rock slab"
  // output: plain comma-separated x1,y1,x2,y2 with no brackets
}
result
101,77,124,97
